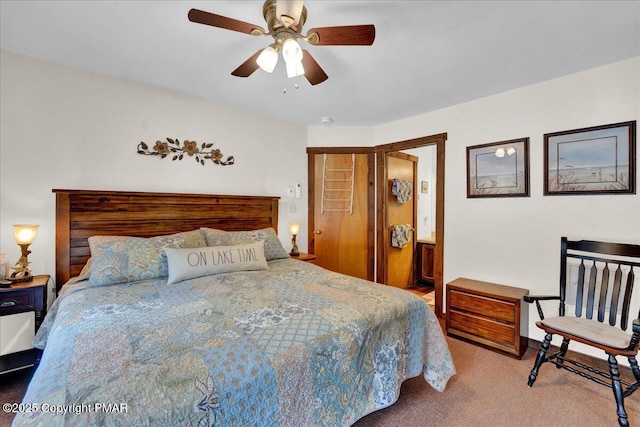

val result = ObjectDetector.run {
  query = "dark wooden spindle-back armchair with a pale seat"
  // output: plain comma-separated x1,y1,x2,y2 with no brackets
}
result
524,237,640,427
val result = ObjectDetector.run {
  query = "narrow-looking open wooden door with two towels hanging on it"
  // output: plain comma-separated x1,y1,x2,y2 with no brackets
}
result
384,152,418,288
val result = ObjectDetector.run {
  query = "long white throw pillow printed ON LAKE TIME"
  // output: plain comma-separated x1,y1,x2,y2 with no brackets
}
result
164,241,269,284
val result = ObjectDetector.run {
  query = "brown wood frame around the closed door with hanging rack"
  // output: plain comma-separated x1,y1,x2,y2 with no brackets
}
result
307,147,376,281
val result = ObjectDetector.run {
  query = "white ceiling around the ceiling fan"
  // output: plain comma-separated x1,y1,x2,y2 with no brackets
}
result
0,0,640,126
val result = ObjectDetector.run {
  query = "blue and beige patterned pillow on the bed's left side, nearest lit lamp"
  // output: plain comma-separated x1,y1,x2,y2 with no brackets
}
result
88,230,207,286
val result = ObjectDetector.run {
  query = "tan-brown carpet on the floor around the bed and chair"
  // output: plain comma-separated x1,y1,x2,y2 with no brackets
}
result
0,320,640,427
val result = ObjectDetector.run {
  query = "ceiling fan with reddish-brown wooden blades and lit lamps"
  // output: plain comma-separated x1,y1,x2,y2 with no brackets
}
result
189,0,376,85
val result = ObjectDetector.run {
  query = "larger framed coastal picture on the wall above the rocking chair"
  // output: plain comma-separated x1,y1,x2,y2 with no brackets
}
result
544,121,636,196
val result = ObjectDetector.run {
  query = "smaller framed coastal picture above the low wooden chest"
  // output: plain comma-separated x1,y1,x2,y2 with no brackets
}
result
467,138,529,198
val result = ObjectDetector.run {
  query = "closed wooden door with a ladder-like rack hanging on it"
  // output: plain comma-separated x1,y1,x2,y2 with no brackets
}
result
309,153,373,280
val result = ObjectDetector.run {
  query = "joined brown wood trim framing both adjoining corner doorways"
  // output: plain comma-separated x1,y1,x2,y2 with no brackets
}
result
307,132,447,318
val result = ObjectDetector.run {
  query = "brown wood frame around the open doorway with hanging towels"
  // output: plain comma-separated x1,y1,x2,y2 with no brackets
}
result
375,133,447,318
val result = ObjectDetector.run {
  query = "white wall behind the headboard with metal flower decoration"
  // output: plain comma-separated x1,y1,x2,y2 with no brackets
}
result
0,50,307,300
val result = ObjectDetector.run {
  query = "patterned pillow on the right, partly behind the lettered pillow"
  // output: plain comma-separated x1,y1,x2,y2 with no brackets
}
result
200,227,289,261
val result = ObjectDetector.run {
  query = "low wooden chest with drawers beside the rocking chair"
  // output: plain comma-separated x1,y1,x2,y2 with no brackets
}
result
446,278,529,359
